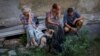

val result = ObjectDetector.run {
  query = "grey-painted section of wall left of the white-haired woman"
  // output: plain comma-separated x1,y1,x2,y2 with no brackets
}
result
0,0,20,27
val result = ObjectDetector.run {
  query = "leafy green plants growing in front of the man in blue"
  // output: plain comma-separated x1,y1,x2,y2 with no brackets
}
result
61,30,89,56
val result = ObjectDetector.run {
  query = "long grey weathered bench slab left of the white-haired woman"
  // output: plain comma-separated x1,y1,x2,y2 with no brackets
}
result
0,25,24,38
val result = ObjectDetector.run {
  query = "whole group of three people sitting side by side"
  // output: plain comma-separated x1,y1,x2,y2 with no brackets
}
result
21,3,83,49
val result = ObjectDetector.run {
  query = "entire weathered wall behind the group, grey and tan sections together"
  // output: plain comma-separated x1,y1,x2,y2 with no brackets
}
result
0,0,100,27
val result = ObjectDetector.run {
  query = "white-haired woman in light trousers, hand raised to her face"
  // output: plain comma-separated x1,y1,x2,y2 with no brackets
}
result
21,7,46,48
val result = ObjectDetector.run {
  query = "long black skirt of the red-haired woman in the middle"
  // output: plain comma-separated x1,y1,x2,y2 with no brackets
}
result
47,24,64,52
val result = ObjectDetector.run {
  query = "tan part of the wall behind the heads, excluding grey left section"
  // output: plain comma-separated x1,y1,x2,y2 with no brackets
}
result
21,0,100,15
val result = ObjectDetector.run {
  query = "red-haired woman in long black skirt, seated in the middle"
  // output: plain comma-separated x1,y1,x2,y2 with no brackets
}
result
45,3,64,52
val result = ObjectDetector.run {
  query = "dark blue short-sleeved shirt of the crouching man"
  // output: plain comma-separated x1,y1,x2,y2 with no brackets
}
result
63,11,80,25
